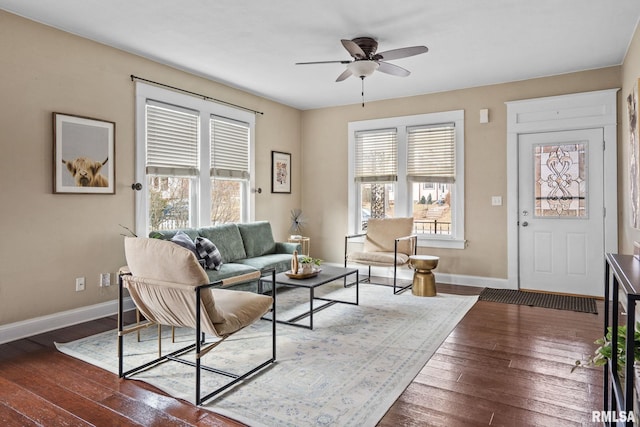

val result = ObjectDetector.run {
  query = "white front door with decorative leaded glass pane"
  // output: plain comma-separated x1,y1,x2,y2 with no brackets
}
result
518,129,604,296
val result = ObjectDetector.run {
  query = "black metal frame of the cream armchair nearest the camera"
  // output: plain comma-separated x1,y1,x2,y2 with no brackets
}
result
118,269,277,406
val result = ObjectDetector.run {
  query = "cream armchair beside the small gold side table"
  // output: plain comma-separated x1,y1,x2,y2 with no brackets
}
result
344,218,418,294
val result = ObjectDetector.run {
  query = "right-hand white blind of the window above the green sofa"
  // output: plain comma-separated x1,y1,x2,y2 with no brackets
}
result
211,116,249,179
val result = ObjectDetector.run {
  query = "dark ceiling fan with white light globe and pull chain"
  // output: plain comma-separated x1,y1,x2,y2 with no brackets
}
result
296,37,429,107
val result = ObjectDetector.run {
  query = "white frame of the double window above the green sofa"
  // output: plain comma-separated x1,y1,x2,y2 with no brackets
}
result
134,82,256,236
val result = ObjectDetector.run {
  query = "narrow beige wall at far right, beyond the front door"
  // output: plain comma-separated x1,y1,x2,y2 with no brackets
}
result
618,20,640,254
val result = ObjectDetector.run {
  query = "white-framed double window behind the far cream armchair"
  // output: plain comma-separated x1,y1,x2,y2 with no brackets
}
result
348,110,464,248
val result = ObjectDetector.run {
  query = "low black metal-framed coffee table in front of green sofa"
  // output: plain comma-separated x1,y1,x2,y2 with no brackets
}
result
258,266,360,329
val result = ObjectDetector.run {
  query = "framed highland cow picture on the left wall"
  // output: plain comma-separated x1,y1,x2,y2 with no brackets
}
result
53,112,116,194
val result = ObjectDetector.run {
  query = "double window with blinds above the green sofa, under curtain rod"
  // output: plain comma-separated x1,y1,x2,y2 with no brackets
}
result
136,83,255,235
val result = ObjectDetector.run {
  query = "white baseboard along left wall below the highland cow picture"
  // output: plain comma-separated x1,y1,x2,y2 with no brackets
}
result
0,297,135,344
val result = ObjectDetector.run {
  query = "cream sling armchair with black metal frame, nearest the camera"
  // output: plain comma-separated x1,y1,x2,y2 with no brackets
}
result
118,237,276,405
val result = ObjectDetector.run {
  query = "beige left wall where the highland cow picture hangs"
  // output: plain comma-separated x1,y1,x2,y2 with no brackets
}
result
0,11,301,325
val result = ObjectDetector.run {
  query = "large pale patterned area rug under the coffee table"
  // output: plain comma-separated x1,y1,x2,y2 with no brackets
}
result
56,284,477,426
